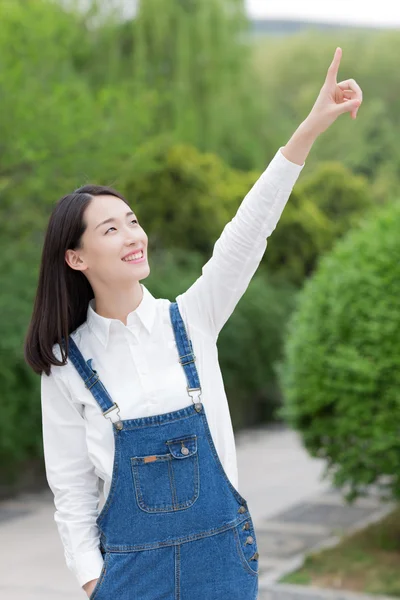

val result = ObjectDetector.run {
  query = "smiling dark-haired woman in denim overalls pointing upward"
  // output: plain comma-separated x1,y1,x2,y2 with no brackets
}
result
25,48,362,600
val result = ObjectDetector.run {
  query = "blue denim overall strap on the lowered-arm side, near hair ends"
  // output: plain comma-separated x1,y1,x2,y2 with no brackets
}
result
62,336,122,429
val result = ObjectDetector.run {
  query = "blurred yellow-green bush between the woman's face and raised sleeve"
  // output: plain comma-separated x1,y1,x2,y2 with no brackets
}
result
120,138,259,256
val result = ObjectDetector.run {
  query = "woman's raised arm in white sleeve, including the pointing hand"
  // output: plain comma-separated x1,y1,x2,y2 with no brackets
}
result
177,48,362,339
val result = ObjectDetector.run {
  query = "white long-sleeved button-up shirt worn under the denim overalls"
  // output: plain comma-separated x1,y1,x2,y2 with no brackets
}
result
41,150,303,586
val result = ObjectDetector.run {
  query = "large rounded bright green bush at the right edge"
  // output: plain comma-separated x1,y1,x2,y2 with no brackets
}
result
279,202,400,499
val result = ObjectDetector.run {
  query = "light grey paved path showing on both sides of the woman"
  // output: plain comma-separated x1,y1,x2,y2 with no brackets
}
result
0,428,394,600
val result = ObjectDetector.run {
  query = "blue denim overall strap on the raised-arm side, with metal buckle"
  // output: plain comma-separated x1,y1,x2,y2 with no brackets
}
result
169,302,201,410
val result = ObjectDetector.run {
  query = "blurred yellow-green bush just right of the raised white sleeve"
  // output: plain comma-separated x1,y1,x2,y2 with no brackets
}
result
267,162,372,285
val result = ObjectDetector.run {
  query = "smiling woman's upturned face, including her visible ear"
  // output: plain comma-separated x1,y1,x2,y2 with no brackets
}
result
66,195,150,285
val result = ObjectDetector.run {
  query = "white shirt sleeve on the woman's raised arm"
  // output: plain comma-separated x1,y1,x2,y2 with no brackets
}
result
177,149,304,338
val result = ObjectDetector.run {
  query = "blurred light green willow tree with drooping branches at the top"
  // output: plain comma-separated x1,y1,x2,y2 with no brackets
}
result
132,0,261,168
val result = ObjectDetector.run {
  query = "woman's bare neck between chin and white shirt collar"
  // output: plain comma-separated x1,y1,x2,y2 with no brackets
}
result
94,281,143,325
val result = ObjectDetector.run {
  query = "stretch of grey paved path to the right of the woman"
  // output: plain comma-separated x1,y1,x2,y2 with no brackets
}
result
236,428,394,600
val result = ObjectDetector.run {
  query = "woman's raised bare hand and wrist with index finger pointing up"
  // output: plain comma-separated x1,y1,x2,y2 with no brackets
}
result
282,48,362,165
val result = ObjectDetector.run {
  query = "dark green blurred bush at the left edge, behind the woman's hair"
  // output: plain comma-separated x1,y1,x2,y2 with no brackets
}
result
0,245,42,486
